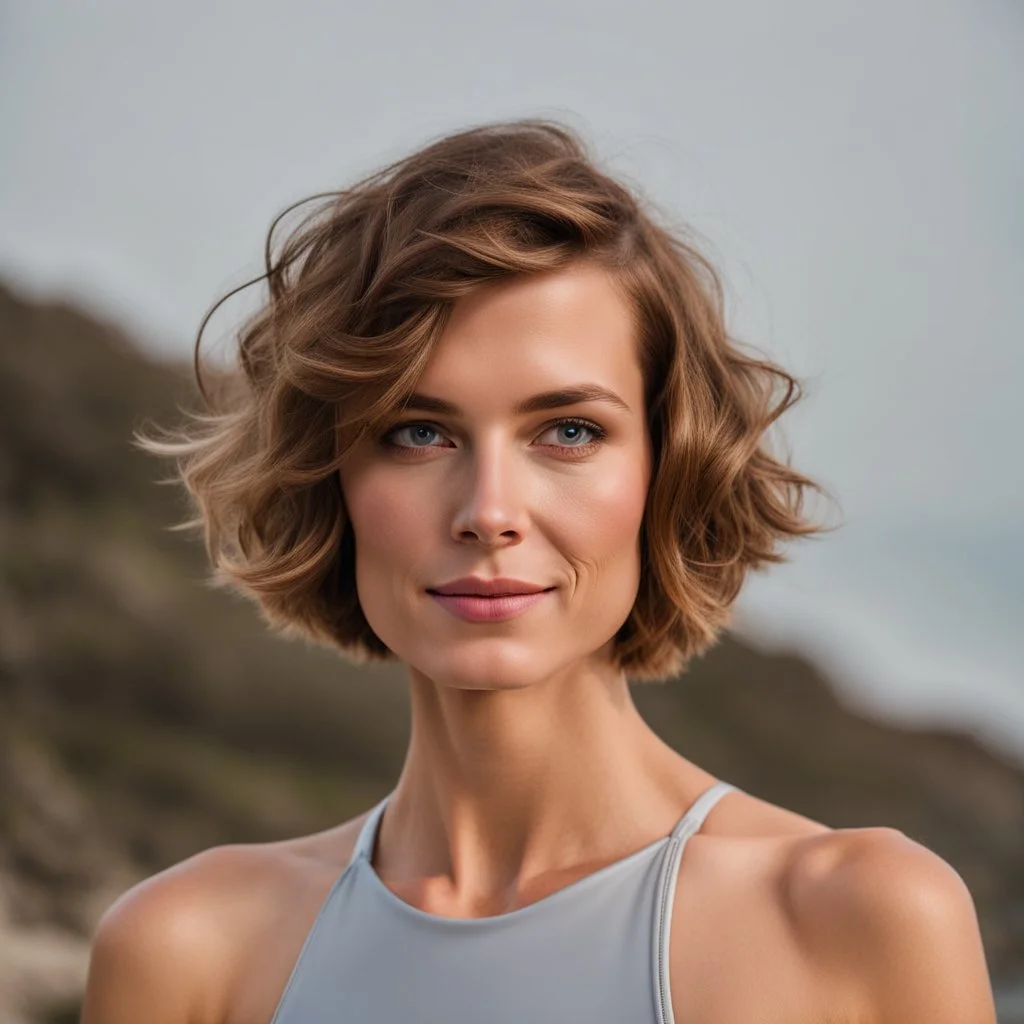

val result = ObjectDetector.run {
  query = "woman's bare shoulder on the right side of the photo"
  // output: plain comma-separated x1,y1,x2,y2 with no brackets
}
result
673,794,990,1022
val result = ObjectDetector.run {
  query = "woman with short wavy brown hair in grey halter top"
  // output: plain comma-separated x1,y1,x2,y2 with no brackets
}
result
83,121,994,1024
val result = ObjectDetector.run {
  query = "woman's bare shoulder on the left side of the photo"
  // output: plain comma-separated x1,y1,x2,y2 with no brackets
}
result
82,811,369,1024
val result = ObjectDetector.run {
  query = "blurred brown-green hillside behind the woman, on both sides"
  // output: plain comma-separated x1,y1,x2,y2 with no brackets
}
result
0,288,1024,1024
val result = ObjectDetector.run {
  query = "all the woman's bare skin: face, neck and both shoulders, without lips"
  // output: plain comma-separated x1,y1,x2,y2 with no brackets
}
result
83,264,995,1024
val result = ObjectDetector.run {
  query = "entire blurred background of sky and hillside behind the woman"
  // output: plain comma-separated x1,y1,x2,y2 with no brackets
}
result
0,0,1024,1024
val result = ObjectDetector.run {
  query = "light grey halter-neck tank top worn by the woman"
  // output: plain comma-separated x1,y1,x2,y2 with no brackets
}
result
271,782,736,1024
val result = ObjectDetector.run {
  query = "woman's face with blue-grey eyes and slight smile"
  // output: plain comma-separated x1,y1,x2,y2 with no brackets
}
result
340,264,651,689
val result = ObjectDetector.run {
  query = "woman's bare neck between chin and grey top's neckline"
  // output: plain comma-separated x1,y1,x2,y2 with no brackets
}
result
374,669,714,906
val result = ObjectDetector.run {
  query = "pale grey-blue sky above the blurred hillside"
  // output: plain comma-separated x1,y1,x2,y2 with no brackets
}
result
0,0,1024,760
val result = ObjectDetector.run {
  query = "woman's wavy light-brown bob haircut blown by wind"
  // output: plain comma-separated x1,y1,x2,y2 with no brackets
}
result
146,119,825,681
